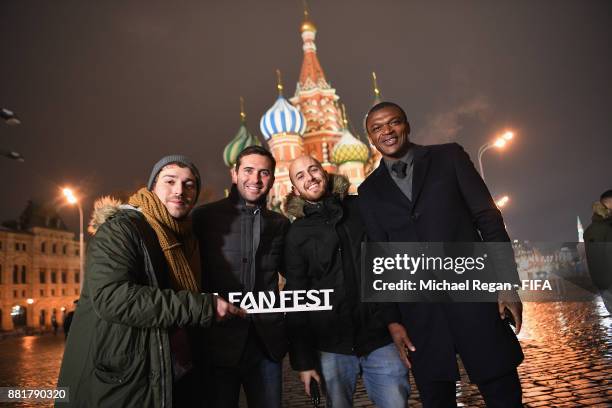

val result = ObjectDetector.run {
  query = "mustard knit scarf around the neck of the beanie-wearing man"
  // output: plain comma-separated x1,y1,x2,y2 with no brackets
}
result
128,187,199,292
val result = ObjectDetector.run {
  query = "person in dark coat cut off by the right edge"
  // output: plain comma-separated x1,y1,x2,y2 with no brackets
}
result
584,190,612,313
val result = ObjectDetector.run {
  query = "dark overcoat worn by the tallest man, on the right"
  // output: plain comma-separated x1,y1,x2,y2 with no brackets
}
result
359,143,523,382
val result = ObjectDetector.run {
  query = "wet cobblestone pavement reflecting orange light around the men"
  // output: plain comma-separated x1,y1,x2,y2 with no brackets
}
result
0,300,612,408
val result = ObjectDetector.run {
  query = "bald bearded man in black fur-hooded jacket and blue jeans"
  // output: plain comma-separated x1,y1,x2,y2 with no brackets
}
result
285,156,410,408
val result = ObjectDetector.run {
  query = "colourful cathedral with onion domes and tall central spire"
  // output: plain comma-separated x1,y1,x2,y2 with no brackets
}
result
223,10,381,210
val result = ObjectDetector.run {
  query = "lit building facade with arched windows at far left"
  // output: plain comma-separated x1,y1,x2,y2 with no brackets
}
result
0,202,80,331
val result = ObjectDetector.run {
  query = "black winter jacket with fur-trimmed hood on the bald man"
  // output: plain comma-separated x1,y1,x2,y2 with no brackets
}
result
285,175,392,371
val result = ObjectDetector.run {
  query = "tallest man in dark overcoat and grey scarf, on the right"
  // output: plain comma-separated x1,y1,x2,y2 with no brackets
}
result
359,102,523,407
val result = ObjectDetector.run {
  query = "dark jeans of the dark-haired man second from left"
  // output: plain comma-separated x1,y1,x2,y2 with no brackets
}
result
209,334,282,408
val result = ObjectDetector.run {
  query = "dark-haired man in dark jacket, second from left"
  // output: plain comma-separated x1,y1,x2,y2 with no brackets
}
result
193,146,289,408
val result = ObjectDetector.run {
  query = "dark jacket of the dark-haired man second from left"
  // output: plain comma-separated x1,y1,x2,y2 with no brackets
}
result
192,185,289,367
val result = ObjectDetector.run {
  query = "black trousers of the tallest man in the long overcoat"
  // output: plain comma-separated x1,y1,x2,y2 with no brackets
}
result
416,370,523,408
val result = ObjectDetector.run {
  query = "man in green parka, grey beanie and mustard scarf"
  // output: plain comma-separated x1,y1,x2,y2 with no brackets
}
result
56,155,245,407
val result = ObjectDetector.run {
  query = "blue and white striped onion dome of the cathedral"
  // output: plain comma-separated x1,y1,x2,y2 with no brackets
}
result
259,95,306,140
